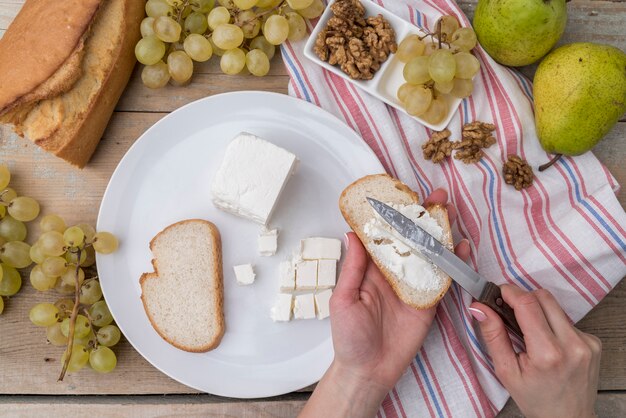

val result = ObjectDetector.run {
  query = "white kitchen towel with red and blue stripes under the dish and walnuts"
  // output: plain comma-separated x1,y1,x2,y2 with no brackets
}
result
283,0,626,417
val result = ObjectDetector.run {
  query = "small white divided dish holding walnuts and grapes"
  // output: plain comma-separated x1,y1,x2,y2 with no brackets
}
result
304,0,461,131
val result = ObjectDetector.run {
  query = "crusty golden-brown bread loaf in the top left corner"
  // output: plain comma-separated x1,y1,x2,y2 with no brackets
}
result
0,0,144,168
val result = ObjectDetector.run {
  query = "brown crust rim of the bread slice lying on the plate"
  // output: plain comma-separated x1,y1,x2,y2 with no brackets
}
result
139,219,226,353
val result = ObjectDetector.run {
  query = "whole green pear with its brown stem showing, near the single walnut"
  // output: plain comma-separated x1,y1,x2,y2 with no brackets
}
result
534,43,626,170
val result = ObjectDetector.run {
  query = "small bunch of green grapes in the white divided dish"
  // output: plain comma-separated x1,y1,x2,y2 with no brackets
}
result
396,16,480,124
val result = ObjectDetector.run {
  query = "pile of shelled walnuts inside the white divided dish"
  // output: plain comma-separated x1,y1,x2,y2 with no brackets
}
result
313,0,398,80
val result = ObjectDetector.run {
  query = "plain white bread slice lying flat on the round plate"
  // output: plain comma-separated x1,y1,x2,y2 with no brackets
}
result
139,219,225,353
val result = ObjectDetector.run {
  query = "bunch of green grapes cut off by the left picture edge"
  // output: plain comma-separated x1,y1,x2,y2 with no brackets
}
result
0,164,39,313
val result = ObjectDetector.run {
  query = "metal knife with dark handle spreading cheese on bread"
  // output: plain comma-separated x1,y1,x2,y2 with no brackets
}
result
367,197,523,338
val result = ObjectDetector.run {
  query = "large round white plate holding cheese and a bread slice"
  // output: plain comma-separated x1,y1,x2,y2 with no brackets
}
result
97,92,383,398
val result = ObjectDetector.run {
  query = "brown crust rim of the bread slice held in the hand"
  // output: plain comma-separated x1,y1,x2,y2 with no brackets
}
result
339,174,453,309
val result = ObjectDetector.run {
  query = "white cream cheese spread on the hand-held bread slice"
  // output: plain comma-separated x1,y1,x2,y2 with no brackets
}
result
363,203,444,291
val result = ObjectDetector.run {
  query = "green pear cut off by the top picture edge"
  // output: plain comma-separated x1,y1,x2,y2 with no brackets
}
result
473,0,567,67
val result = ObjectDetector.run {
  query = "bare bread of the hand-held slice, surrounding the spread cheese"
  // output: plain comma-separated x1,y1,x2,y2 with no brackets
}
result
339,174,453,309
